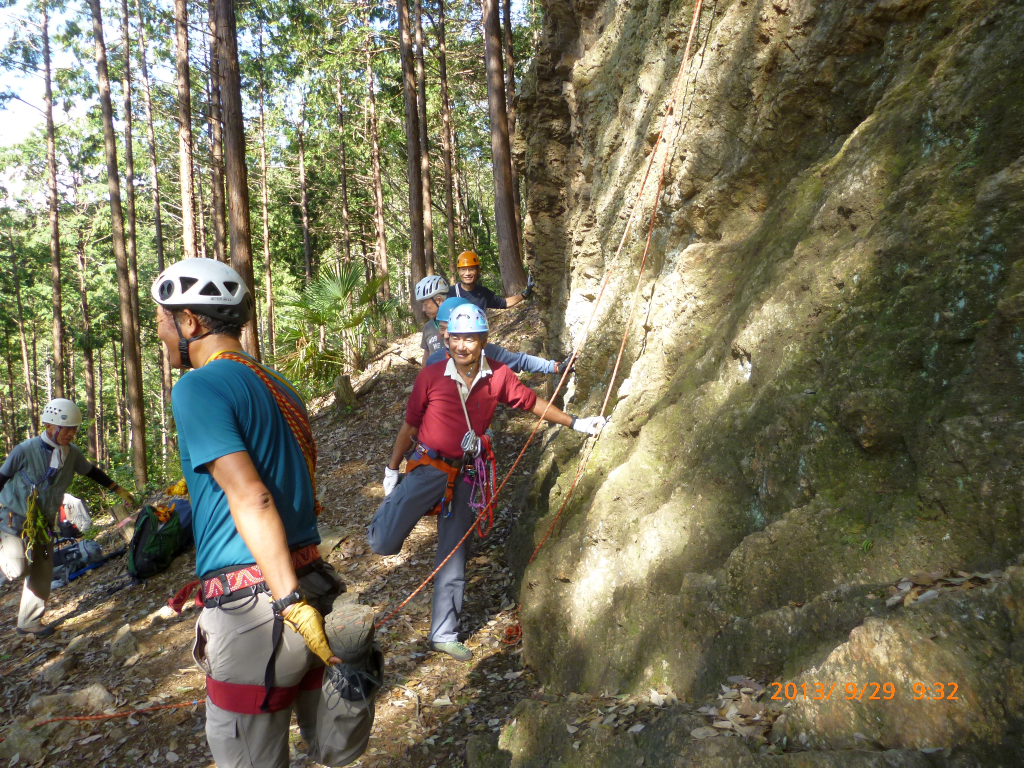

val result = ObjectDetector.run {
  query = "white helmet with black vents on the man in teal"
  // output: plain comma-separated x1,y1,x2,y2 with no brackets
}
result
151,259,253,326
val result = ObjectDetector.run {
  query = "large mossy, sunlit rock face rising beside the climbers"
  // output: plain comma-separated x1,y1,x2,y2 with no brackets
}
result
513,0,1024,765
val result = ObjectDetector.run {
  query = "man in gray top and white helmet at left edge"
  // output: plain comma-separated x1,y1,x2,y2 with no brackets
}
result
0,397,135,637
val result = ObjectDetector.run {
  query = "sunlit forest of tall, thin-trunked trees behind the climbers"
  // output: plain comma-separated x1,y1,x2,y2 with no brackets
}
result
0,0,540,488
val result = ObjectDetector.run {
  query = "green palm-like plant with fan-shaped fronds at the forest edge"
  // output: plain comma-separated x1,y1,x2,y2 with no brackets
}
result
274,261,402,395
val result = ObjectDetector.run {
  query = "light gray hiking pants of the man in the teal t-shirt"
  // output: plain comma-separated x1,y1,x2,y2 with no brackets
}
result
193,571,376,768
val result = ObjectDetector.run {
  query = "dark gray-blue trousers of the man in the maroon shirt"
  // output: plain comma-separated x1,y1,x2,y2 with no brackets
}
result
367,465,475,643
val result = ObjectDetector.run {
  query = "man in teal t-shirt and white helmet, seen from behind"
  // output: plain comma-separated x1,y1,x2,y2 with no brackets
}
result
153,259,384,768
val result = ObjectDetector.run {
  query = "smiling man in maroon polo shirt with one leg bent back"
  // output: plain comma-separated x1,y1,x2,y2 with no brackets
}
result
368,304,604,662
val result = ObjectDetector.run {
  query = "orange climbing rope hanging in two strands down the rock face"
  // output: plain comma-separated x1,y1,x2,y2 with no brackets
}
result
375,0,702,629
